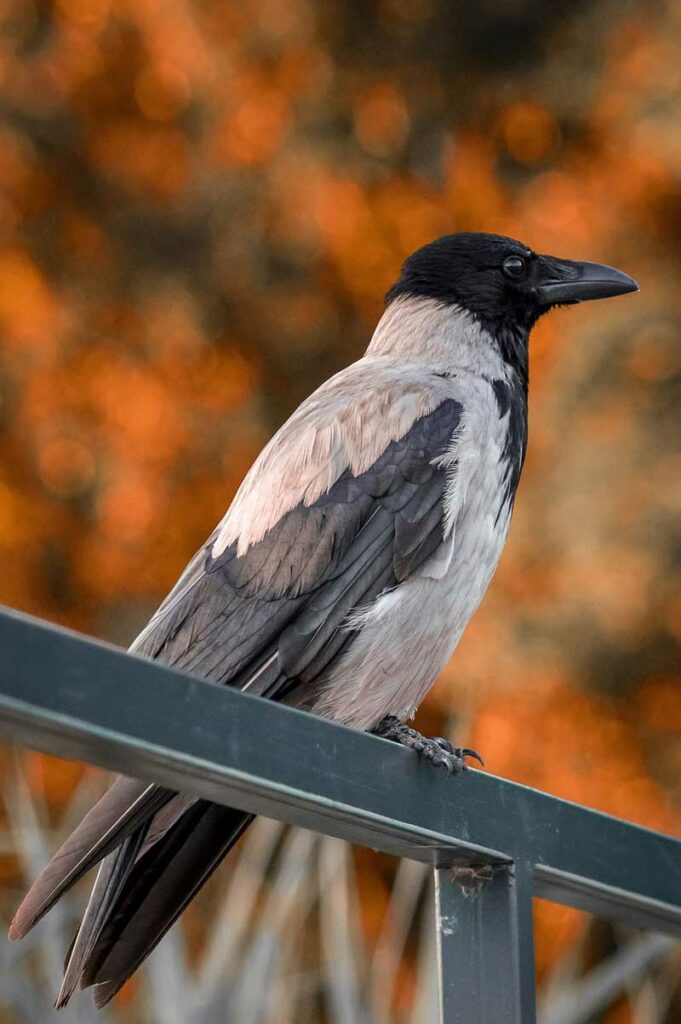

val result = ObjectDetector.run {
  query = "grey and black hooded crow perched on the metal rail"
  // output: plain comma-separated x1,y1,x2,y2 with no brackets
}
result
9,232,638,1007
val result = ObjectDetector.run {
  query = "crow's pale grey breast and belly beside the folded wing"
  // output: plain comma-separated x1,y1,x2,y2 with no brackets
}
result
311,371,526,728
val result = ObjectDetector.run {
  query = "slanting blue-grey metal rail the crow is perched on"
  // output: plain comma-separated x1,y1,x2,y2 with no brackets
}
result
0,611,681,934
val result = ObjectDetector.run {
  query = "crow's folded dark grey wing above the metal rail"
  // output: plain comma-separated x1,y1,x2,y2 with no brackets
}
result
133,399,462,697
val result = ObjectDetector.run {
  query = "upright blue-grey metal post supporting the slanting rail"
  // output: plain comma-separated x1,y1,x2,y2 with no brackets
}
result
435,865,536,1024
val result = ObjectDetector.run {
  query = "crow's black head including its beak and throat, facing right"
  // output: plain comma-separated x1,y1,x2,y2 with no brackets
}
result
387,232,638,369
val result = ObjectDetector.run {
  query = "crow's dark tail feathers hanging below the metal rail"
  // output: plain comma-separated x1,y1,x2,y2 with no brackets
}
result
9,779,253,1008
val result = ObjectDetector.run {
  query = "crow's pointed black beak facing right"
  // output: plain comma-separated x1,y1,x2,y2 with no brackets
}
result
535,256,638,306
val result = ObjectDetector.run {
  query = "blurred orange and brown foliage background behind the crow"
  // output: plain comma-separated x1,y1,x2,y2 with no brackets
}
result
0,0,681,1024
